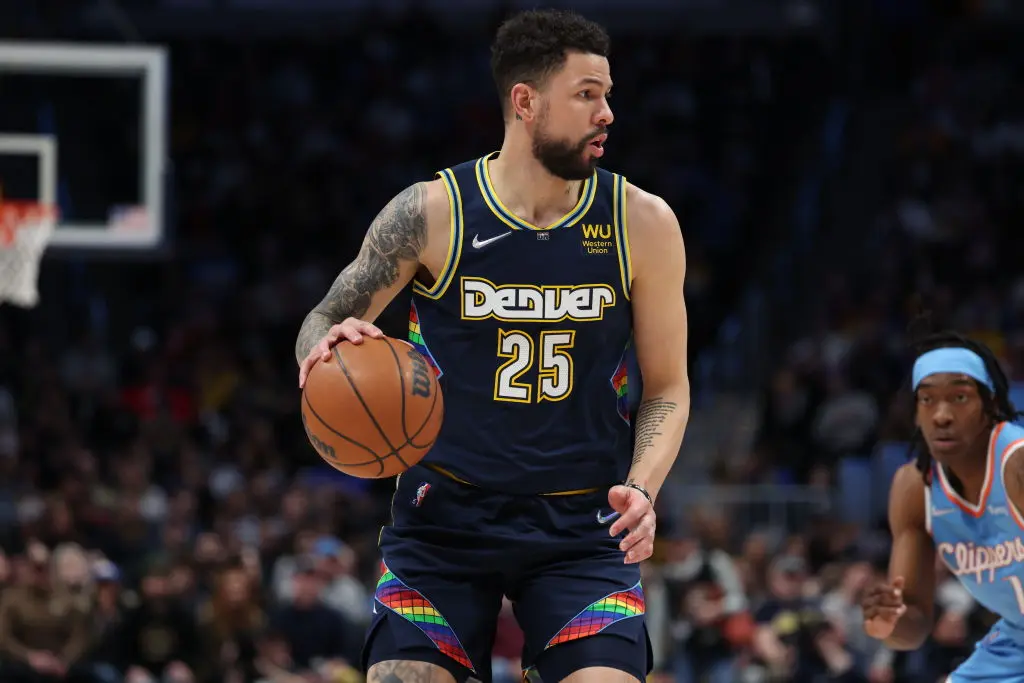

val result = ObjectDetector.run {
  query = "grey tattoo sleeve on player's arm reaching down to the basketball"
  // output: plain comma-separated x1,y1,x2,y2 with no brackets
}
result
295,183,427,362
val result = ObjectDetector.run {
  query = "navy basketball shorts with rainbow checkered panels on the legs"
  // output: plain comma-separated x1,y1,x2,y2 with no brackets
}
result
362,466,651,683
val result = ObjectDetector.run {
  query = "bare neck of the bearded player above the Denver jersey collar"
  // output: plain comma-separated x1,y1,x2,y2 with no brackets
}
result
487,139,583,222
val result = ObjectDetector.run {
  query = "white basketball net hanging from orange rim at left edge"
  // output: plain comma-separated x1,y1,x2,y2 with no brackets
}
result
0,188,56,308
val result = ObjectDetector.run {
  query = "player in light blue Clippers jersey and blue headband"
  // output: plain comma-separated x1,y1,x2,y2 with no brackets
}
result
863,334,1024,683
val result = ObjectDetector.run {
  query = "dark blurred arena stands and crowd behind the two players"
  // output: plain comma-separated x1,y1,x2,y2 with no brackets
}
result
0,0,1024,683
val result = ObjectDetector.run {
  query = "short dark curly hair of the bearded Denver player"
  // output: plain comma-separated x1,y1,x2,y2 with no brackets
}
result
490,9,611,116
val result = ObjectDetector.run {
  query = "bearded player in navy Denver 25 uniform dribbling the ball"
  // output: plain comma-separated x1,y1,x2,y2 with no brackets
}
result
296,11,689,683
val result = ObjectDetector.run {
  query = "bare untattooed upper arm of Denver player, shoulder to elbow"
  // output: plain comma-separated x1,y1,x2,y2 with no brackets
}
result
630,198,687,386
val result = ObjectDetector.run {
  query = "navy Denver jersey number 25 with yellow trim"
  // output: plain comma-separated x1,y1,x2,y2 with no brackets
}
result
410,154,633,494
